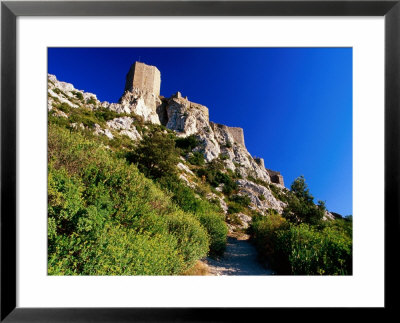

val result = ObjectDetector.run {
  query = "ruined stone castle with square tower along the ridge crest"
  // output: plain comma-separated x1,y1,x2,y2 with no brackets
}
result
120,62,284,186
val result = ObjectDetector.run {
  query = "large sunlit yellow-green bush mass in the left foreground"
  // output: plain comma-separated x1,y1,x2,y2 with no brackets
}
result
48,124,210,275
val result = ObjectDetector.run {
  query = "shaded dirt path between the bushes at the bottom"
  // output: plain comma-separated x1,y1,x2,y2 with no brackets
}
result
205,236,274,276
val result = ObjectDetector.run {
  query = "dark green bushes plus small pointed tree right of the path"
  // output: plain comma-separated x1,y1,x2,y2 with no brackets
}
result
250,176,352,275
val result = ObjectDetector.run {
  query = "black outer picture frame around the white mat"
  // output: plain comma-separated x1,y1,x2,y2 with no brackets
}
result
0,0,400,322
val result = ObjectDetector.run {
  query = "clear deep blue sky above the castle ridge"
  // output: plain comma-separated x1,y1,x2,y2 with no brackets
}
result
48,48,352,215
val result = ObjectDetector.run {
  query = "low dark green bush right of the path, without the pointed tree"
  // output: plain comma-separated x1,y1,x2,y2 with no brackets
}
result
251,215,352,275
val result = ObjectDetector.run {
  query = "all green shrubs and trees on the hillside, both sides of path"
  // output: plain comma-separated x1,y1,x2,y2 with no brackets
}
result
48,89,352,275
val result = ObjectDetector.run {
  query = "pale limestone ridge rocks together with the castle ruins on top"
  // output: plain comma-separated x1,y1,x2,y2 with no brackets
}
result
48,62,290,222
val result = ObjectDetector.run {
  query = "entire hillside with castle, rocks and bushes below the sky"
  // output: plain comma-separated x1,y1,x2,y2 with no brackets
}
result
48,62,352,275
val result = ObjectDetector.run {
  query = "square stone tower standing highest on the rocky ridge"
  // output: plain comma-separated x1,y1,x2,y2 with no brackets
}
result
125,62,161,96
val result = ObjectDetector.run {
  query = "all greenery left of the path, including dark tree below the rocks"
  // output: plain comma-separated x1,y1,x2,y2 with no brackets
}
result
48,92,227,275
